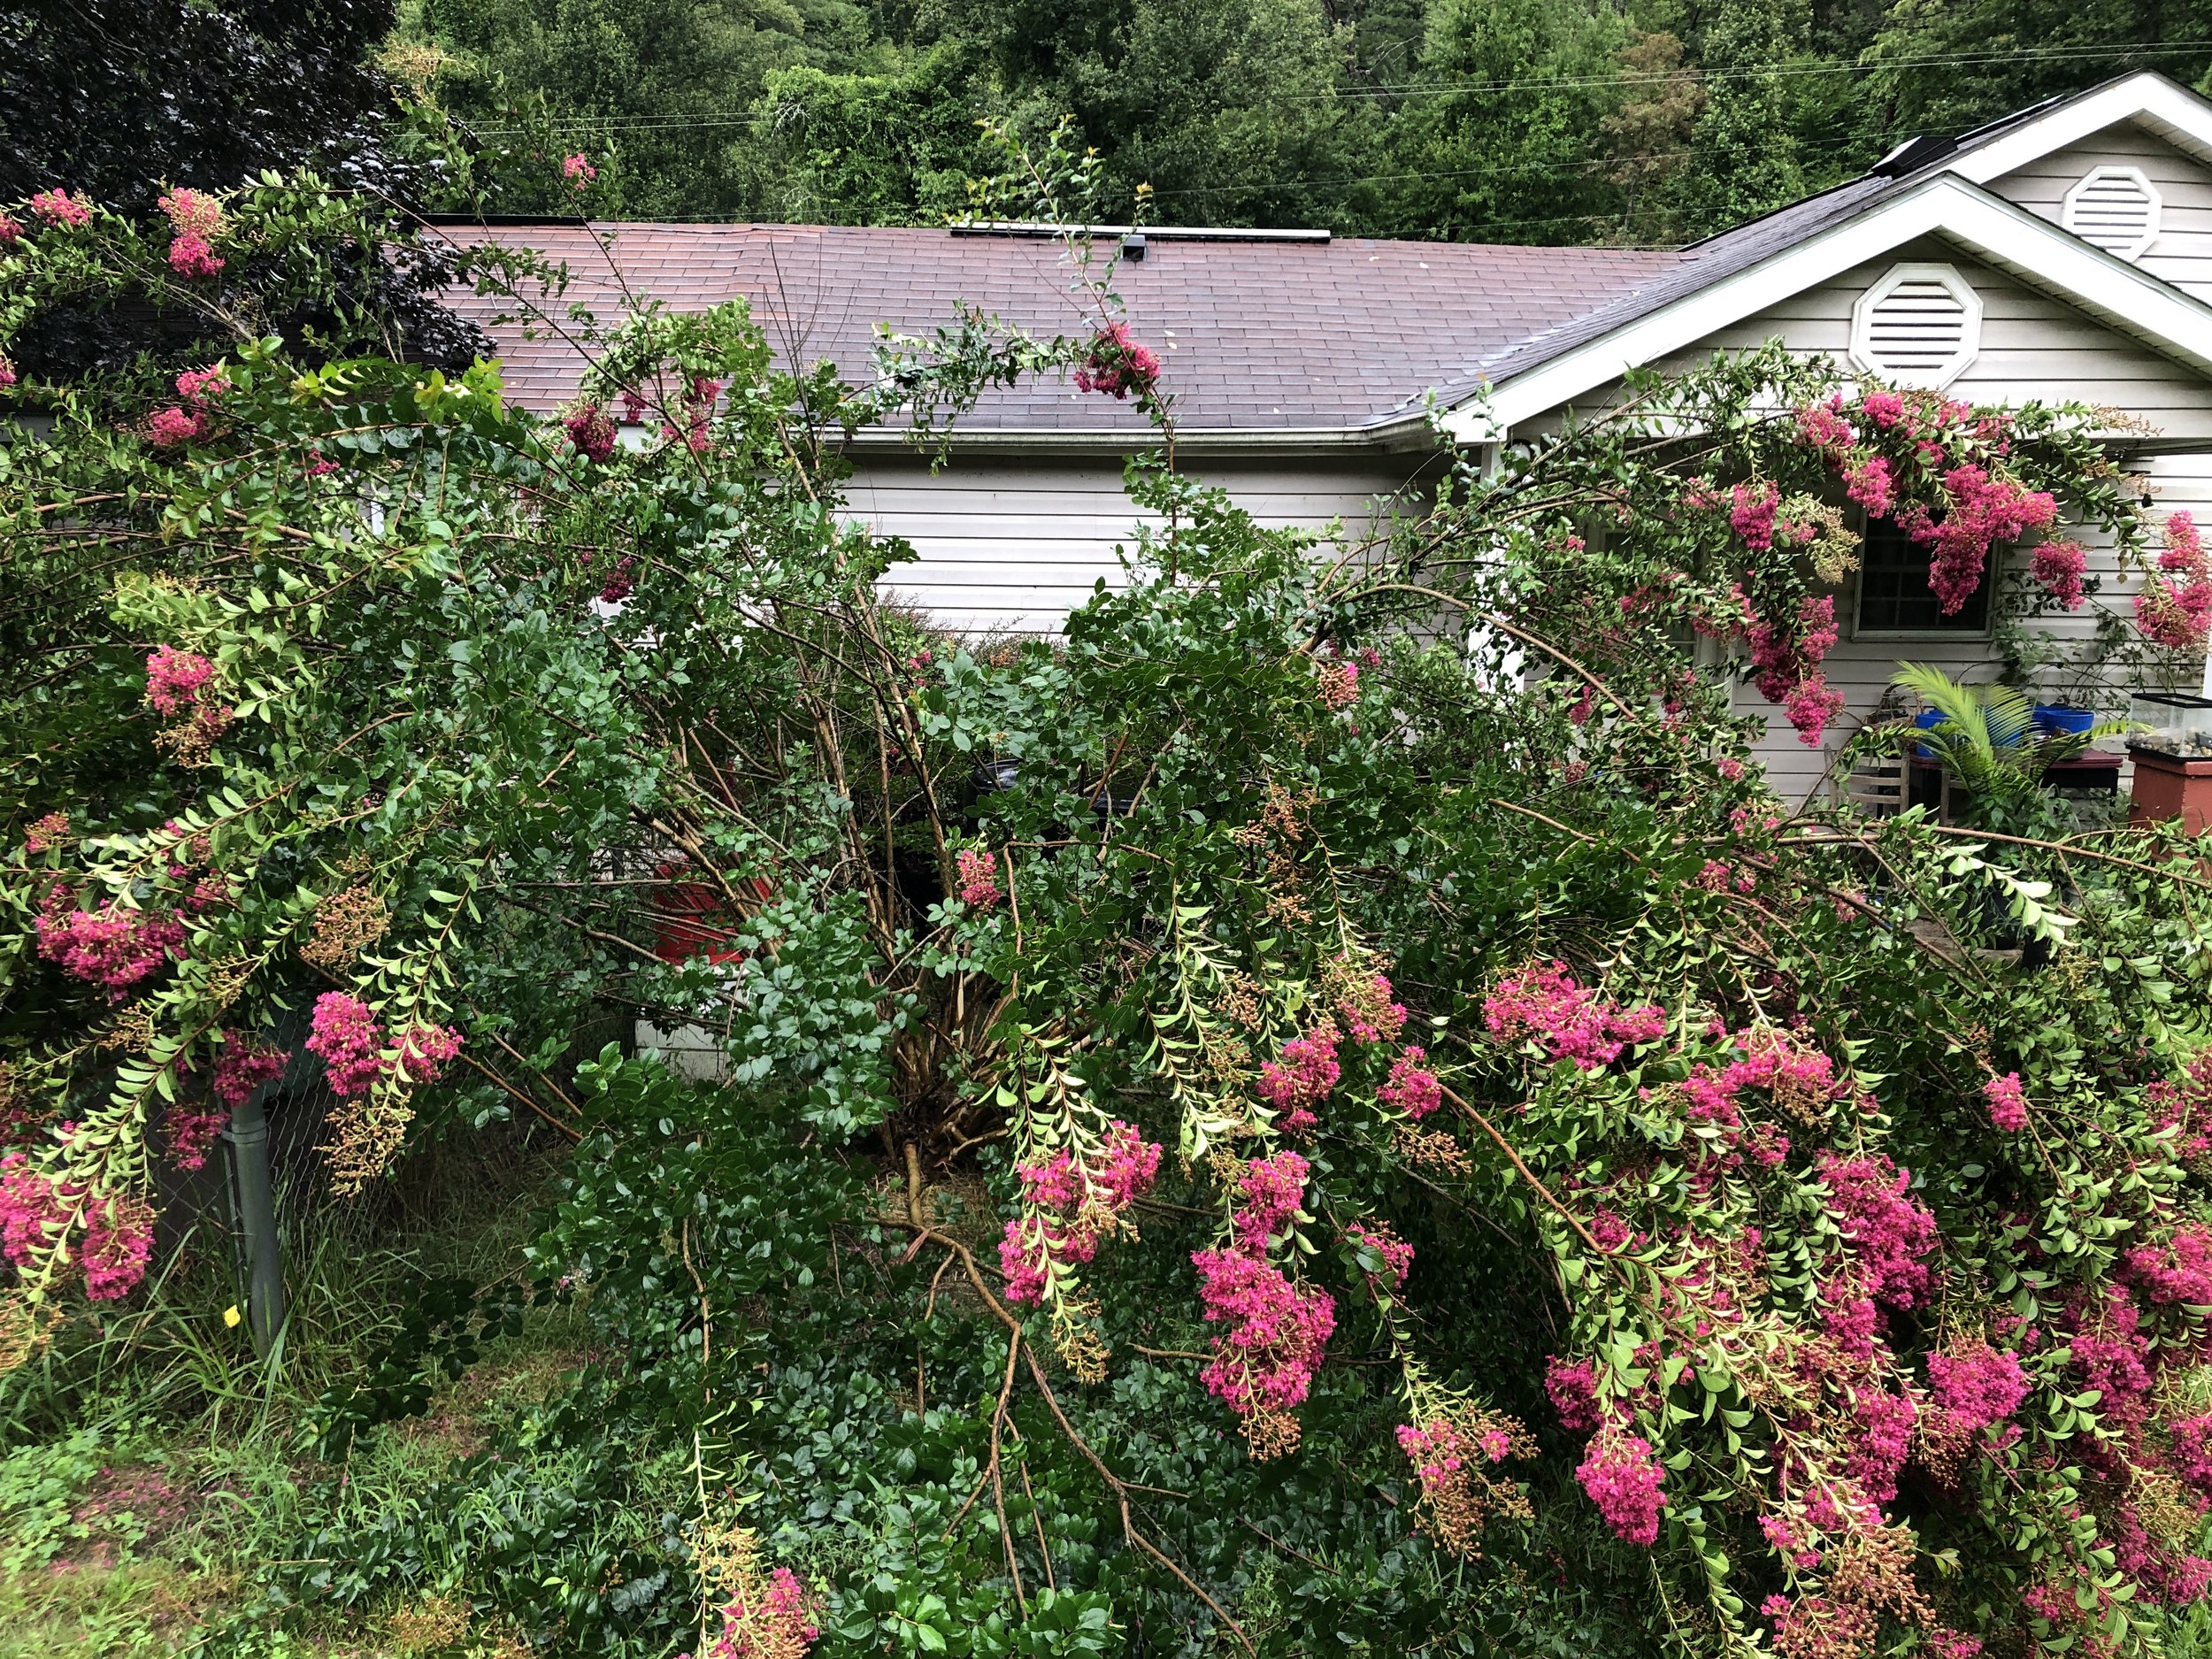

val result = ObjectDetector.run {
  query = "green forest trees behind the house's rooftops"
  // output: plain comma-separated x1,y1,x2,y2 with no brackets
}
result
388,0,2212,243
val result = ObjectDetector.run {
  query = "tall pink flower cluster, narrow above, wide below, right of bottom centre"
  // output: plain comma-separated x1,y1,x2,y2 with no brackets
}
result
1190,1153,1336,1418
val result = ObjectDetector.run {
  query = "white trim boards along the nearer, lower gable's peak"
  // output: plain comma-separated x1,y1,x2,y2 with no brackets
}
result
1445,173,2212,442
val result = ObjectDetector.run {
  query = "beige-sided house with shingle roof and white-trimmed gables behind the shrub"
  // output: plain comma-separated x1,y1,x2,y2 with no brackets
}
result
435,73,2212,796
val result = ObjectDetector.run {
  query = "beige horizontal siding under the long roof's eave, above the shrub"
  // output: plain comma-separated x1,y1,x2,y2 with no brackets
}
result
848,454,1433,633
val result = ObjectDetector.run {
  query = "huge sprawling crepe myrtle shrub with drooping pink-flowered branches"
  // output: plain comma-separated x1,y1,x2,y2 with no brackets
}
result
12,181,2212,1659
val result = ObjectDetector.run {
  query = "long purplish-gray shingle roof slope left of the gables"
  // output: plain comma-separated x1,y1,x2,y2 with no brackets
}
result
445,224,1684,436
